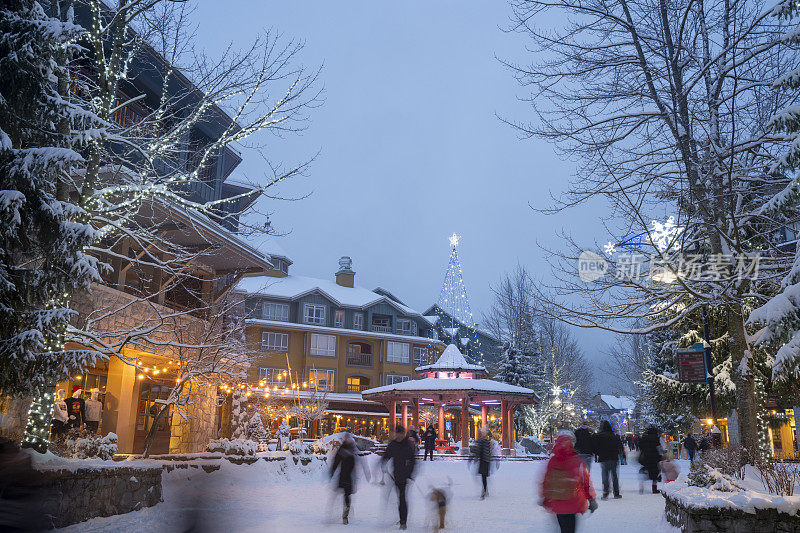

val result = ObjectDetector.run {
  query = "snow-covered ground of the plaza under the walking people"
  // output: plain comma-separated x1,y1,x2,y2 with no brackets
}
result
65,456,687,533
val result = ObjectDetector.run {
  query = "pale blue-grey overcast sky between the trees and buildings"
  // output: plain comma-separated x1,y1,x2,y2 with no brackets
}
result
194,0,614,389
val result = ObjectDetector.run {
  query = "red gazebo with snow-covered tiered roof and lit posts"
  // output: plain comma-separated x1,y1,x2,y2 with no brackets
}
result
361,344,537,450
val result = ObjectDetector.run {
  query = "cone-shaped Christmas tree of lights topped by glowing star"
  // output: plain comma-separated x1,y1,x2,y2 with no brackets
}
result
437,233,485,364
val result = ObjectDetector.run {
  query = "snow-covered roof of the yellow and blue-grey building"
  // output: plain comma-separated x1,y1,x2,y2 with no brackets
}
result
236,275,422,318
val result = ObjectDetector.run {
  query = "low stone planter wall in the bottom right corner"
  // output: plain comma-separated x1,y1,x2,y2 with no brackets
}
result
664,495,800,533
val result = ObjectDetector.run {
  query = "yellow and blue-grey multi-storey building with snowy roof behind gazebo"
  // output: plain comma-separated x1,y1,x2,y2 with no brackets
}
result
241,252,444,437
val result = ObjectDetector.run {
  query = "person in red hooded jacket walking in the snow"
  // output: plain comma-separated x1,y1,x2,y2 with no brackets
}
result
541,435,597,533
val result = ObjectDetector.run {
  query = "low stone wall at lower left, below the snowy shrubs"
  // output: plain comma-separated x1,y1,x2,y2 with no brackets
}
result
33,467,162,527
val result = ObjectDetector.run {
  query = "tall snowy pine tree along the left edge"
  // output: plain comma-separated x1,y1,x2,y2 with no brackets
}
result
0,0,99,450
